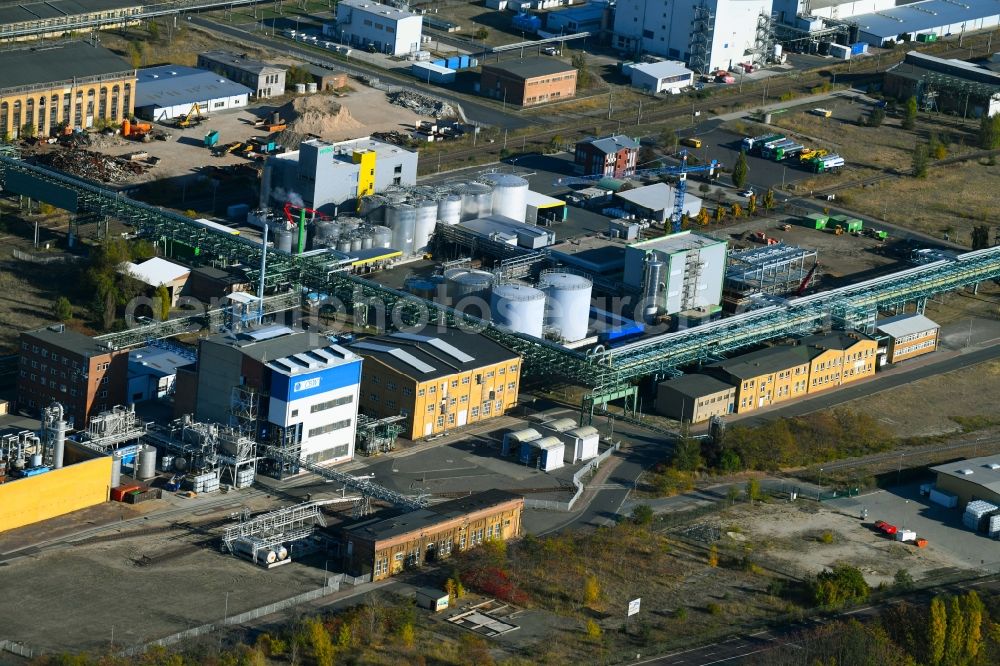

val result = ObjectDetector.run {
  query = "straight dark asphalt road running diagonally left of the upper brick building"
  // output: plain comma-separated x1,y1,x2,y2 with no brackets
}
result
190,16,532,129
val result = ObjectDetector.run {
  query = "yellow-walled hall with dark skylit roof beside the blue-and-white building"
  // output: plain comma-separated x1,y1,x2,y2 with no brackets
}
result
349,329,521,439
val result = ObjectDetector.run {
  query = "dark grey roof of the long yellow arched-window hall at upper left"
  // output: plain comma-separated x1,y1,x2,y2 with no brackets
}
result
0,42,135,90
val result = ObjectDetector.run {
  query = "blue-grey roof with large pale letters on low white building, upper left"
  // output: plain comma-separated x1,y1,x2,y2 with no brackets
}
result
135,65,254,110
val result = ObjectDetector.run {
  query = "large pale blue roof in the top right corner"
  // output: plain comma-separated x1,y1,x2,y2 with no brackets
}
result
850,0,1000,39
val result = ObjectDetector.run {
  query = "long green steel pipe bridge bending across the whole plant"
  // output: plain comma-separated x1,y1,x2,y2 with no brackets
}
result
0,156,1000,416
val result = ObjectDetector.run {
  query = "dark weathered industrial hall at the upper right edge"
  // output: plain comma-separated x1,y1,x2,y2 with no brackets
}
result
883,51,1000,118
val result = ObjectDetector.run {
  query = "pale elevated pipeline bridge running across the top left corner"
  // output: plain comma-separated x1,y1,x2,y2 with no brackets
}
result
0,0,270,41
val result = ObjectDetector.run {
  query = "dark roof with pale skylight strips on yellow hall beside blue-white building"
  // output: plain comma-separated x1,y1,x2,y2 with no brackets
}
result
347,327,520,382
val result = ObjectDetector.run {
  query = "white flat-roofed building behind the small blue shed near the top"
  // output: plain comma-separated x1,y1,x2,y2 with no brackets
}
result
323,0,424,56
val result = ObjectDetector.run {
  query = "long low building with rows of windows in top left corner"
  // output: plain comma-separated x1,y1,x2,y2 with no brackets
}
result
0,0,143,42
